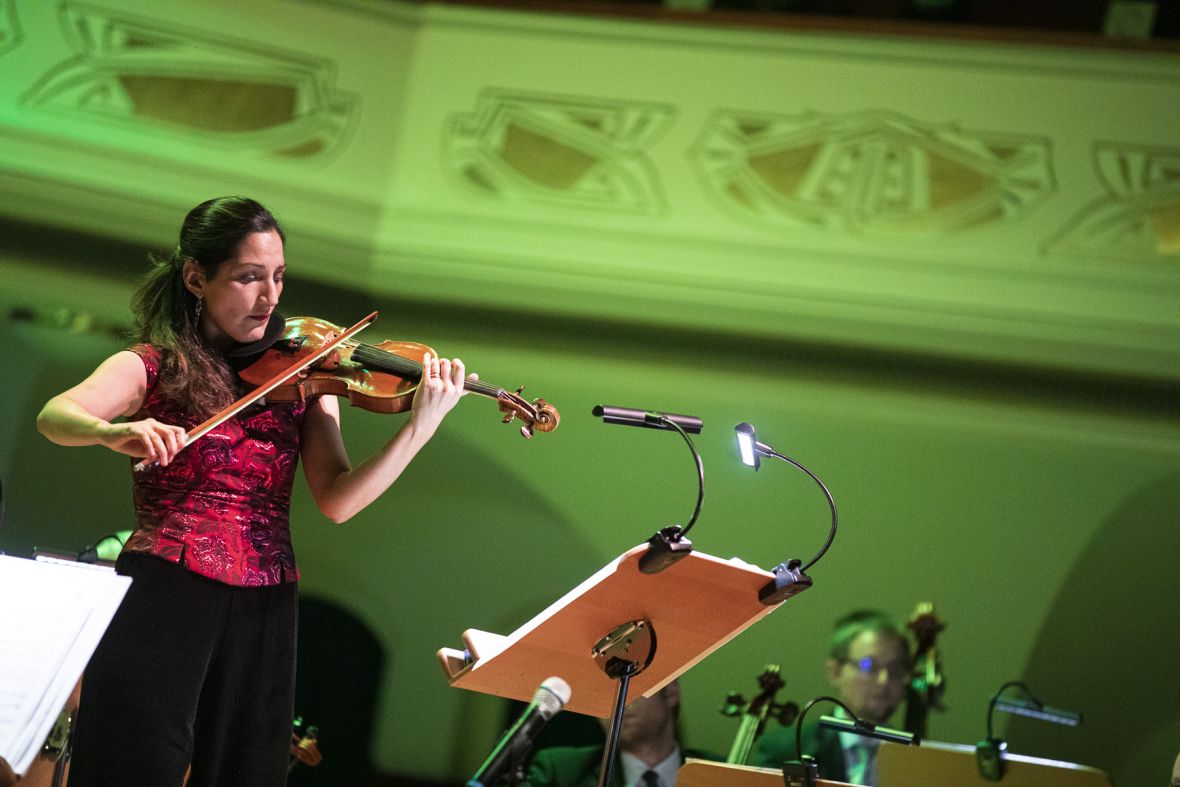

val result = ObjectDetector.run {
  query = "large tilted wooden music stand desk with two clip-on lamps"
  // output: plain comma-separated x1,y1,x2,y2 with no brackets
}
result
438,543,802,783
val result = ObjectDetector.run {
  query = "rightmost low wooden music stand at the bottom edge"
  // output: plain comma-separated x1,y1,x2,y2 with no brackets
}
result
877,741,1113,787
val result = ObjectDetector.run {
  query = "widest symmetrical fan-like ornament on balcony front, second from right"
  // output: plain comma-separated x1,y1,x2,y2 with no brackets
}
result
693,111,1055,242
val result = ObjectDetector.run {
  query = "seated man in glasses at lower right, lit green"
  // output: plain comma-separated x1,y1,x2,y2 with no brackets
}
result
750,610,911,785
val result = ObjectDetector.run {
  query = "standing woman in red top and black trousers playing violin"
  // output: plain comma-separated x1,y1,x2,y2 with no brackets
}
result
38,197,476,787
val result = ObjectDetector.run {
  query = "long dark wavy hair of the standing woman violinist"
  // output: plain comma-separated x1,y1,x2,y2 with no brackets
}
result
131,197,287,415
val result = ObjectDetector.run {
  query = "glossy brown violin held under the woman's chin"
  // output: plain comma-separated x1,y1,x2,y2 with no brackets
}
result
238,317,561,438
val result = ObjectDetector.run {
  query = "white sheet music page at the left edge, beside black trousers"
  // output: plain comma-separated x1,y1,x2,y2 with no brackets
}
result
0,555,131,774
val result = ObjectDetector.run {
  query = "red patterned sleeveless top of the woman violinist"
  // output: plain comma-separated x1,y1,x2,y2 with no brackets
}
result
123,345,307,586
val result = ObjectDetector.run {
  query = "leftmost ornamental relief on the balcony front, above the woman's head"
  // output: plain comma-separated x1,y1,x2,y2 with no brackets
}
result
20,2,358,160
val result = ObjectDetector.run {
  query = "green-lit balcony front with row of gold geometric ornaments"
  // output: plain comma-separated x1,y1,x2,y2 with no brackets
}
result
0,0,1180,380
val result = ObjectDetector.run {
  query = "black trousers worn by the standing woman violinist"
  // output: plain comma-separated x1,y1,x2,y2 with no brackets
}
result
70,552,299,787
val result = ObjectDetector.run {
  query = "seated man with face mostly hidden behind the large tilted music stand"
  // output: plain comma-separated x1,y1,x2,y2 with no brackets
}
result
526,681,717,787
